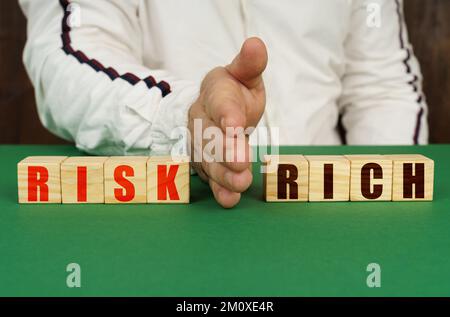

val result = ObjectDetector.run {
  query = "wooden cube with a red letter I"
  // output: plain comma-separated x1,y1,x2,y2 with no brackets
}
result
61,156,108,204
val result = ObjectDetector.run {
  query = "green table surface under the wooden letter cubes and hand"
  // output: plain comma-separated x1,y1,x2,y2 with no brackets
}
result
0,145,450,296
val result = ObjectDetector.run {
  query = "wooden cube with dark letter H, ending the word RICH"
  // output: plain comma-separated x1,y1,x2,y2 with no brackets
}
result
386,154,434,201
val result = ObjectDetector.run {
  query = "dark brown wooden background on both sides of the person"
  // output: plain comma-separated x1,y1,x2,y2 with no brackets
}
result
0,0,450,144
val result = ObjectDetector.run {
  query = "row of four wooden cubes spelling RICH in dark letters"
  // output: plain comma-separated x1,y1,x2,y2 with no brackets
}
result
263,155,434,202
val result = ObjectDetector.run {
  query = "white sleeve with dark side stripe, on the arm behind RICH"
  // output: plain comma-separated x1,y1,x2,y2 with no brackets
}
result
339,0,428,144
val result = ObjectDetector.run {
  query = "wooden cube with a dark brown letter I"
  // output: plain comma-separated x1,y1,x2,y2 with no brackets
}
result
305,155,350,201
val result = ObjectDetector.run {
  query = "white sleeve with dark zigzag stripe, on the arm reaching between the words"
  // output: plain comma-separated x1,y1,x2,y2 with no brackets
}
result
20,0,199,155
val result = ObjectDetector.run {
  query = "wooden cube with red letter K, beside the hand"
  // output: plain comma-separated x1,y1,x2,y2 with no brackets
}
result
147,156,191,204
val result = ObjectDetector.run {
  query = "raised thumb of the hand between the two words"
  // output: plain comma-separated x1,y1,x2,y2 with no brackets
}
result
226,37,268,89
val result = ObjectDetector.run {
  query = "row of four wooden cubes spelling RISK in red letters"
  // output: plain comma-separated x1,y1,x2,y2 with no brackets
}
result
17,156,190,204
